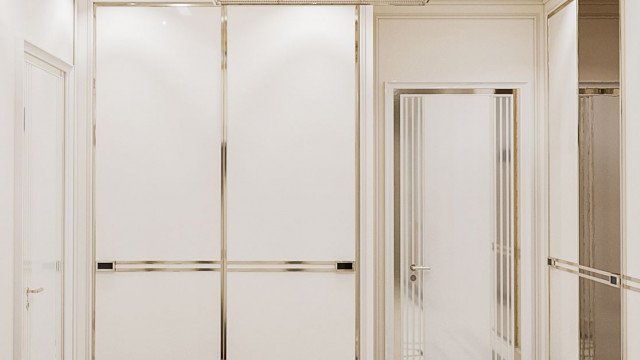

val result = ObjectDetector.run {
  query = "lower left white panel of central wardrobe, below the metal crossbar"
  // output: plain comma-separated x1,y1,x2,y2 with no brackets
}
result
95,272,220,360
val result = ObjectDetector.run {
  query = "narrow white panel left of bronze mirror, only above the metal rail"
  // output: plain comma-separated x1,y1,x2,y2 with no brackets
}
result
548,1,579,262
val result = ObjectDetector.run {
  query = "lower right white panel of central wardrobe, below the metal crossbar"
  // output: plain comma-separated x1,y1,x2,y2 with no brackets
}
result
227,273,355,360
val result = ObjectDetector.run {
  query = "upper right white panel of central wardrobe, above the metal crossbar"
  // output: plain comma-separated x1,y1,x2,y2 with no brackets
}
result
228,6,356,260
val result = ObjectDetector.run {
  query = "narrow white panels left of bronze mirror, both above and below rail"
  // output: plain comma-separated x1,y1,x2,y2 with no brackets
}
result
548,1,579,360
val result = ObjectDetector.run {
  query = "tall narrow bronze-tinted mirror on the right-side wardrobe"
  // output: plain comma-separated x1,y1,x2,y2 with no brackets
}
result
578,0,621,360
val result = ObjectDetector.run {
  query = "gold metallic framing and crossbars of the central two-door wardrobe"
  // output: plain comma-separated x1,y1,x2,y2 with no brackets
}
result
90,0,362,360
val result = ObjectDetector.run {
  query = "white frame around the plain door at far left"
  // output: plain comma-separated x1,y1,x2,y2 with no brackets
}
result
13,39,75,360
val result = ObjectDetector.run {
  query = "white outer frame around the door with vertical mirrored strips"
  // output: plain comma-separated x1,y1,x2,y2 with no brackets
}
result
384,82,544,359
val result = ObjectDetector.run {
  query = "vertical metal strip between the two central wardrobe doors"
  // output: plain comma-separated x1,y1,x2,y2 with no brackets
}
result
220,5,227,360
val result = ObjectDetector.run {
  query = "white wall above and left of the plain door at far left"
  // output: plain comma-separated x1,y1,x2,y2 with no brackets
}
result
0,0,74,359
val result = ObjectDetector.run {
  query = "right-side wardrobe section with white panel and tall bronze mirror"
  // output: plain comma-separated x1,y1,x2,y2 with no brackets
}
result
548,0,624,360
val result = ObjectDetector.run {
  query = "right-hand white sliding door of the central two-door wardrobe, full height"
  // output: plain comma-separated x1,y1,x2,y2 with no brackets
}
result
226,6,357,360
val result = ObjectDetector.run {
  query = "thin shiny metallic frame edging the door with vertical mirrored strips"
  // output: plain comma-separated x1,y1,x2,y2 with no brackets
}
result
393,88,520,360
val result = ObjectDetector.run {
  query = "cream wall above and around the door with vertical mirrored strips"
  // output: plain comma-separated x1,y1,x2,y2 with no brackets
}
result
374,3,544,359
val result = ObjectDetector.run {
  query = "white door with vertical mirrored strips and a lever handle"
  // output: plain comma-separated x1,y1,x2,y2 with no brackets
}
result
394,89,517,360
